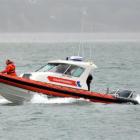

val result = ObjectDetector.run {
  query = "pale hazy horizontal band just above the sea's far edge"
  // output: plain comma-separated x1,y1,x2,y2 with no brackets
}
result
0,33,140,43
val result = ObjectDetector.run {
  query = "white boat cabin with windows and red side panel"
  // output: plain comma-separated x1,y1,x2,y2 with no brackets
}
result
21,56,96,90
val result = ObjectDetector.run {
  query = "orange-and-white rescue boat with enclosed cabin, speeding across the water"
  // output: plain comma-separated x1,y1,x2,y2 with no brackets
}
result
0,56,138,104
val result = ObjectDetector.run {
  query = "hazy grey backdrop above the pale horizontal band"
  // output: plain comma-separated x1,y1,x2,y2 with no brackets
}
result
0,0,140,32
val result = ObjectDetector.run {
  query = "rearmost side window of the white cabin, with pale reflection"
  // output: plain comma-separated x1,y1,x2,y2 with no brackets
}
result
65,65,84,77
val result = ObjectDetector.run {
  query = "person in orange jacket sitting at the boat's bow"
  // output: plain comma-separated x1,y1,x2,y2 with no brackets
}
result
1,59,17,76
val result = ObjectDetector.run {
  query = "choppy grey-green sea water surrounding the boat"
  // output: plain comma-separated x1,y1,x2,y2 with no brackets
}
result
0,42,140,140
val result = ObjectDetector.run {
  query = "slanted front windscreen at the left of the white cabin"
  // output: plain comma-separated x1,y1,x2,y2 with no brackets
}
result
37,63,58,72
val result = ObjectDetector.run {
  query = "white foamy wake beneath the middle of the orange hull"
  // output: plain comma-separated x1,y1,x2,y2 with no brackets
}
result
30,93,86,104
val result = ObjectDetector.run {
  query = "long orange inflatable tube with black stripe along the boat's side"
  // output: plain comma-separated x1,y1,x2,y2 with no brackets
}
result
0,74,137,104
